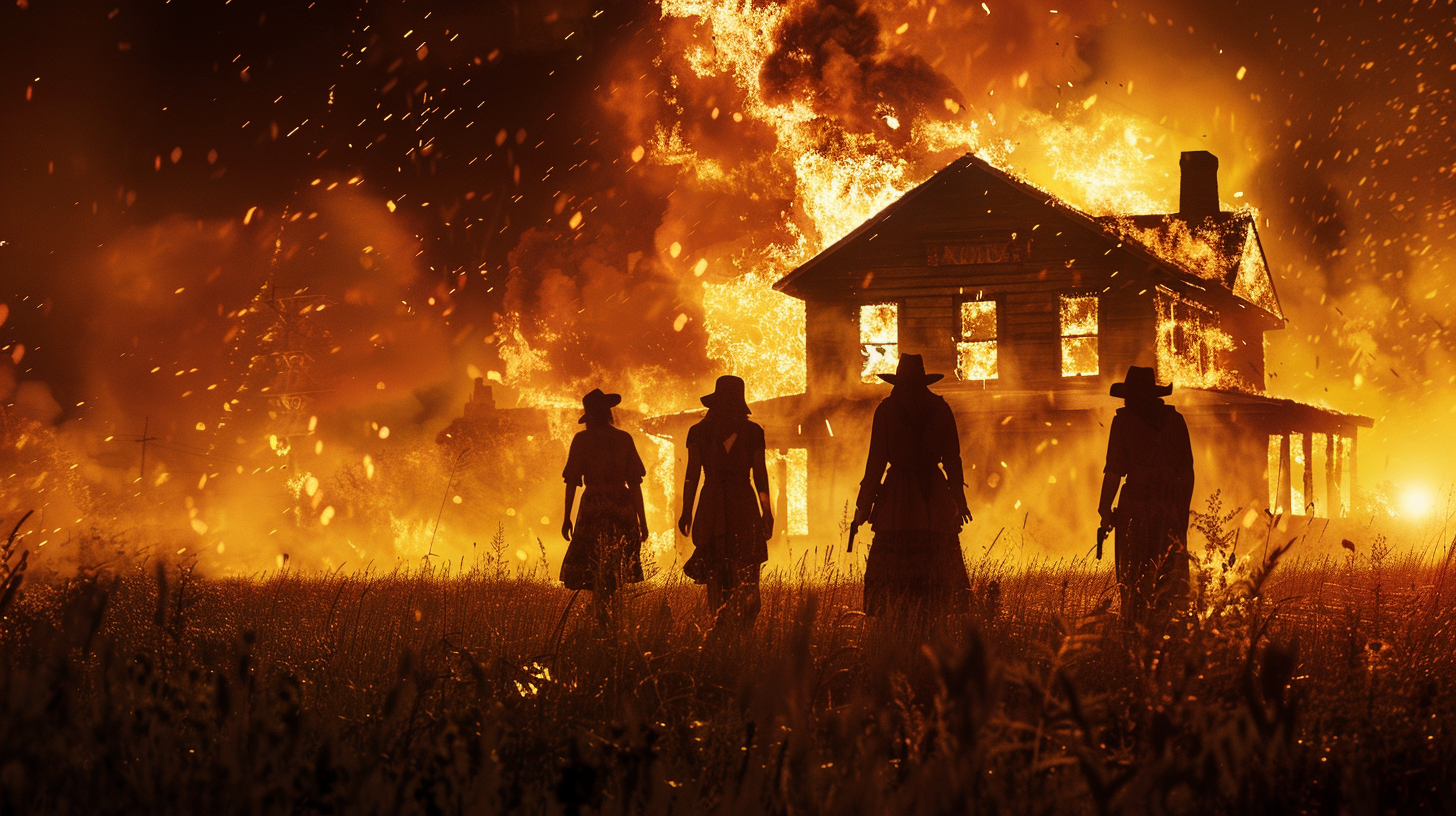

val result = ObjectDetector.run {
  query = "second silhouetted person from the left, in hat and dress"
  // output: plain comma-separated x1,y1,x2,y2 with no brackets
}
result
677,376,773,625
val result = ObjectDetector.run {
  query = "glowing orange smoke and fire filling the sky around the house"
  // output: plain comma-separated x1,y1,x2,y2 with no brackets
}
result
0,0,1456,574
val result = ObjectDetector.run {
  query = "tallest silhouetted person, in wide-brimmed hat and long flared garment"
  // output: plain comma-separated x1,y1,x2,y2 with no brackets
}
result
855,354,971,615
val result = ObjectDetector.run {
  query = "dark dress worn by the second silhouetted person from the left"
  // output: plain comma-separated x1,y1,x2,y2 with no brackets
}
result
683,411,769,590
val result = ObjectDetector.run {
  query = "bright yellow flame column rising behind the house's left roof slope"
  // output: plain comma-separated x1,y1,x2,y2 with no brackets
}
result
654,0,980,399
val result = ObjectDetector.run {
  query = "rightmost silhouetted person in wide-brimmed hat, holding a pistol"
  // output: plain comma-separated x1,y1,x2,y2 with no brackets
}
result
1098,366,1192,628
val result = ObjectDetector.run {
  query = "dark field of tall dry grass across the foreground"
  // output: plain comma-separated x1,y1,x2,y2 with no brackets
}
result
0,507,1456,813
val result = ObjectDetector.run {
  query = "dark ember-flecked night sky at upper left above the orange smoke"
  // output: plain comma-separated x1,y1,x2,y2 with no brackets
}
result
0,0,651,405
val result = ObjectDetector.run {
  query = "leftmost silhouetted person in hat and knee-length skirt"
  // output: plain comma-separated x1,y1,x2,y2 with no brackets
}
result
561,388,646,621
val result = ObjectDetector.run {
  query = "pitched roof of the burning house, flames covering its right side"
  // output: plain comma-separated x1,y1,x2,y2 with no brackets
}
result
773,153,1284,323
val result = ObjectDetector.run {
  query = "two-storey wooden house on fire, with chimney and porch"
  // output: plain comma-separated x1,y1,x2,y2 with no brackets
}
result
649,152,1372,536
